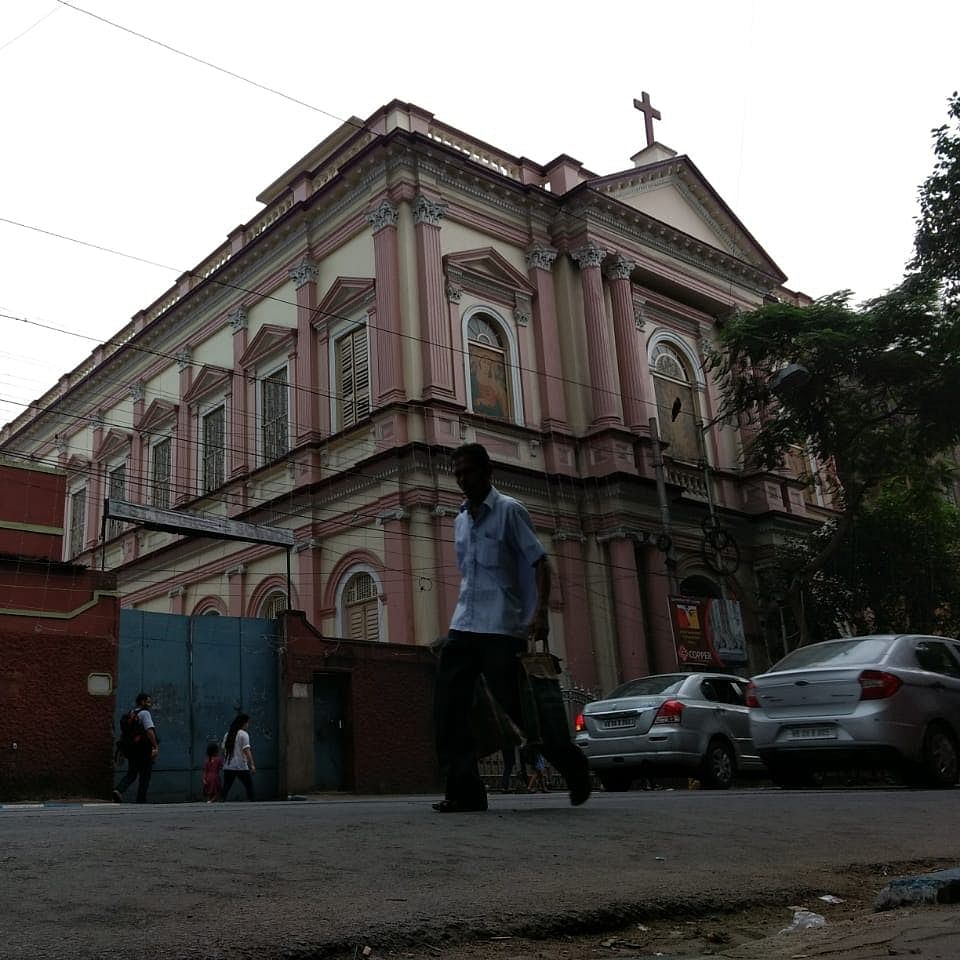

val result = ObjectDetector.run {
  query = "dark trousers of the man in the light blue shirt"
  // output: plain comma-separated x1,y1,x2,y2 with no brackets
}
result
434,630,587,805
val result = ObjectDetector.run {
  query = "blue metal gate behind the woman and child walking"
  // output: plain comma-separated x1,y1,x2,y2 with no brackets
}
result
116,610,279,802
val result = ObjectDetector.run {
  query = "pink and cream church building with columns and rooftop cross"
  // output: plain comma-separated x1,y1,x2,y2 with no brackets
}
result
0,94,829,691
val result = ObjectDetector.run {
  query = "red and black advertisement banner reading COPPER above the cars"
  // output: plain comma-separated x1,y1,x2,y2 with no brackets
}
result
670,597,747,667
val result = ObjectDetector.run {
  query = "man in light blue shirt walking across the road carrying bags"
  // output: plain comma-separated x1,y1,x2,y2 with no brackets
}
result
433,443,590,813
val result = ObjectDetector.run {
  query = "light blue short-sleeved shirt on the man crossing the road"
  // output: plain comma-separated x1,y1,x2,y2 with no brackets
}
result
450,487,546,637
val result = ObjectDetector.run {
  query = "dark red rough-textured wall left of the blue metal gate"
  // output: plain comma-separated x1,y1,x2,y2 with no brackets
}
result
0,558,119,800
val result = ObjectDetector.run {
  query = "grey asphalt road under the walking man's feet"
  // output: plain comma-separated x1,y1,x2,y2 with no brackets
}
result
0,790,960,960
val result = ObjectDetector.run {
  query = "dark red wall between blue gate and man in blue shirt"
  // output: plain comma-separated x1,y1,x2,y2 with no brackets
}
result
285,612,439,793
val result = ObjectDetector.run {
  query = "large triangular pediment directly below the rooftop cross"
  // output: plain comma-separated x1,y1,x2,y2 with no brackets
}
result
590,154,786,282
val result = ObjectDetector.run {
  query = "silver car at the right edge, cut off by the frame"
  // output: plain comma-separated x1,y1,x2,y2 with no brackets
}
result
747,635,960,787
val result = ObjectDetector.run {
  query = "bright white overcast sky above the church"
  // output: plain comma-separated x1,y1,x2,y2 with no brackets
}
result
0,0,960,423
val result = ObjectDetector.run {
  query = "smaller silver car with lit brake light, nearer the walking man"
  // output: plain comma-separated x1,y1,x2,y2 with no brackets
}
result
574,673,762,790
